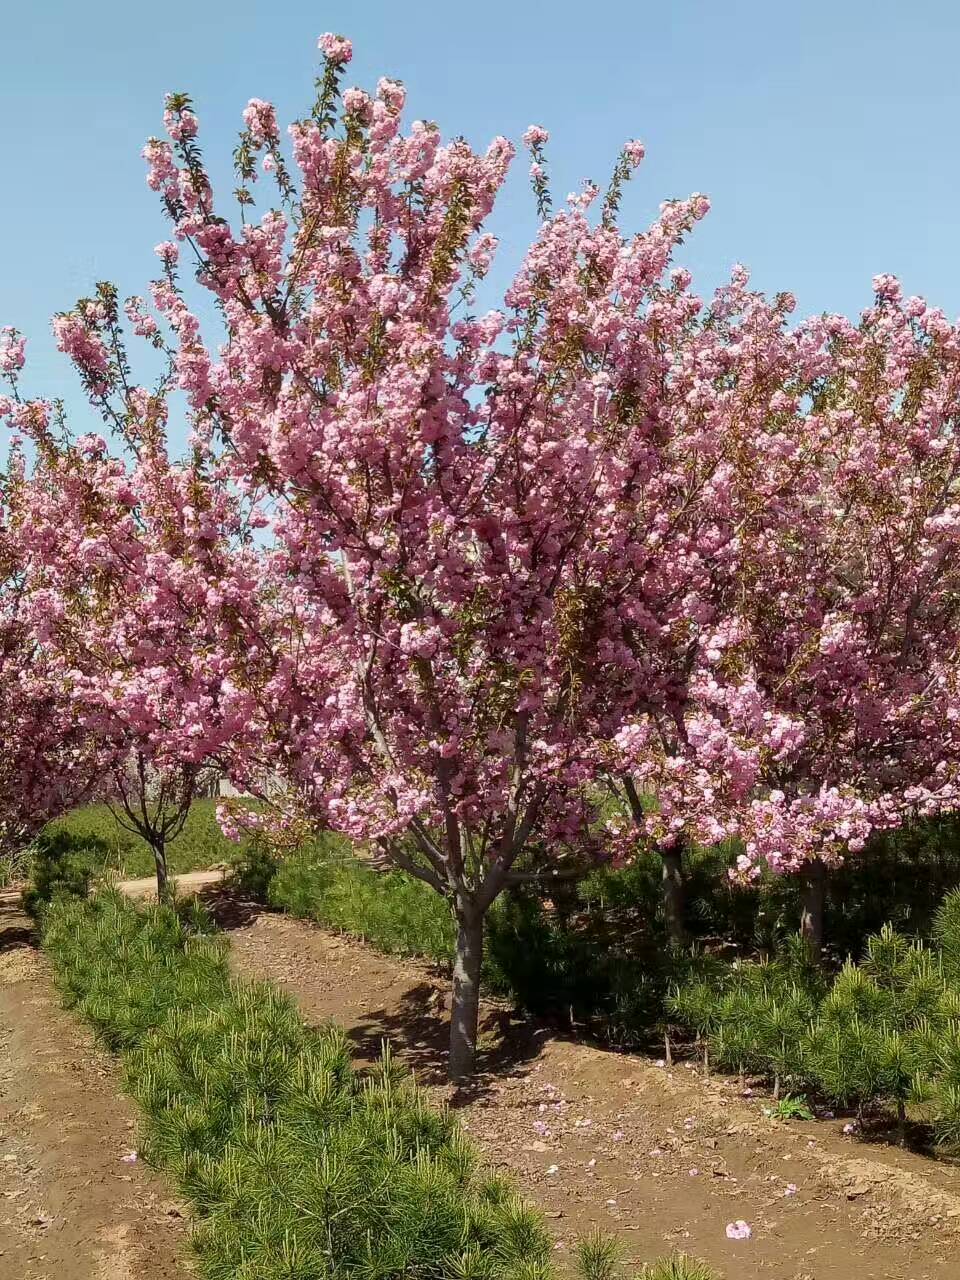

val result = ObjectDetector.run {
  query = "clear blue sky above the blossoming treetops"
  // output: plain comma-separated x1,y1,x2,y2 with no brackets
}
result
0,0,960,419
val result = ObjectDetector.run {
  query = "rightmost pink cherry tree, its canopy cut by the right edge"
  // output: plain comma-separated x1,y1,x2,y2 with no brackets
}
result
716,276,960,945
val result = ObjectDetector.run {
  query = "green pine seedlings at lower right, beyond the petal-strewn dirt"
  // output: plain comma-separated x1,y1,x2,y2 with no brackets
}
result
667,891,960,1155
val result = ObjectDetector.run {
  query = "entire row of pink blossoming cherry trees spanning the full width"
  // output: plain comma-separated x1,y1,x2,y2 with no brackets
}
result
0,36,960,1078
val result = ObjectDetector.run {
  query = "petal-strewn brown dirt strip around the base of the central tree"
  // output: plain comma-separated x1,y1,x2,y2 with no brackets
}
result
221,911,960,1280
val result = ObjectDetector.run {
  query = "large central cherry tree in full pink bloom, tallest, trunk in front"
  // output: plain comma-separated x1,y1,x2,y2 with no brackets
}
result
116,36,783,1078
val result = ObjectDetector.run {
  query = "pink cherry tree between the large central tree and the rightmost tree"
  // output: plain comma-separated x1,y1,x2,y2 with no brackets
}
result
598,266,804,943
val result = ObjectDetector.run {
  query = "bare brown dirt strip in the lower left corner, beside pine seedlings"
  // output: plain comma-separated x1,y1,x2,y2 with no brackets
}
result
0,893,189,1280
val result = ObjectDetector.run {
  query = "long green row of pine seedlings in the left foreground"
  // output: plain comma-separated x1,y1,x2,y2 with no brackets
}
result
42,892,709,1280
